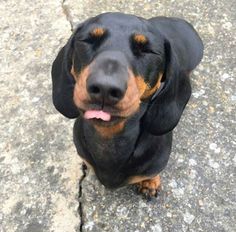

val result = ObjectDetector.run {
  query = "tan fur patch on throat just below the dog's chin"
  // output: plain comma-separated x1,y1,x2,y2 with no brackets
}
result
94,120,125,139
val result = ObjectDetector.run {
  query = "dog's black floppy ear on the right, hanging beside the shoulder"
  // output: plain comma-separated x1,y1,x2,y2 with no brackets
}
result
143,40,191,135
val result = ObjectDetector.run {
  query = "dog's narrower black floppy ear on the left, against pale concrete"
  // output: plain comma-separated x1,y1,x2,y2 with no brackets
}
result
51,32,79,118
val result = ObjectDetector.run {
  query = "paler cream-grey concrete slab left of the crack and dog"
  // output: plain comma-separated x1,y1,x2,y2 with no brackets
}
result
0,0,80,232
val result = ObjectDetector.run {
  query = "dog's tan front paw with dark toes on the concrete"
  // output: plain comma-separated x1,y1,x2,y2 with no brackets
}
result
137,175,161,198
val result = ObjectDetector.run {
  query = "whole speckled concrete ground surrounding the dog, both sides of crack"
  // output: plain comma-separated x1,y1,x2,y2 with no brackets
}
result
0,0,236,232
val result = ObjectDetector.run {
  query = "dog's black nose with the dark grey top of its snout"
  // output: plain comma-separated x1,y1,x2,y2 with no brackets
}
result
87,51,128,105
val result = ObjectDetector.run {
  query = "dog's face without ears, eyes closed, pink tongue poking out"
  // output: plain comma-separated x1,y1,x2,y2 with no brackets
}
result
71,13,165,126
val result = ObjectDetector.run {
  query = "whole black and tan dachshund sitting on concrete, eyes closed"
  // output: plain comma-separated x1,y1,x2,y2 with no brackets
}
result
52,13,203,196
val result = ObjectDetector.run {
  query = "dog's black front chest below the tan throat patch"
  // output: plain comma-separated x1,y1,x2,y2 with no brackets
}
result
79,120,139,187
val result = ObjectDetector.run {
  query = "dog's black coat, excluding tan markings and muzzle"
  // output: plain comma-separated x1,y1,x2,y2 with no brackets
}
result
52,13,203,188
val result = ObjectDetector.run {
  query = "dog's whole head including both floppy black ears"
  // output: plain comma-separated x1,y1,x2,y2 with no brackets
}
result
52,13,203,134
